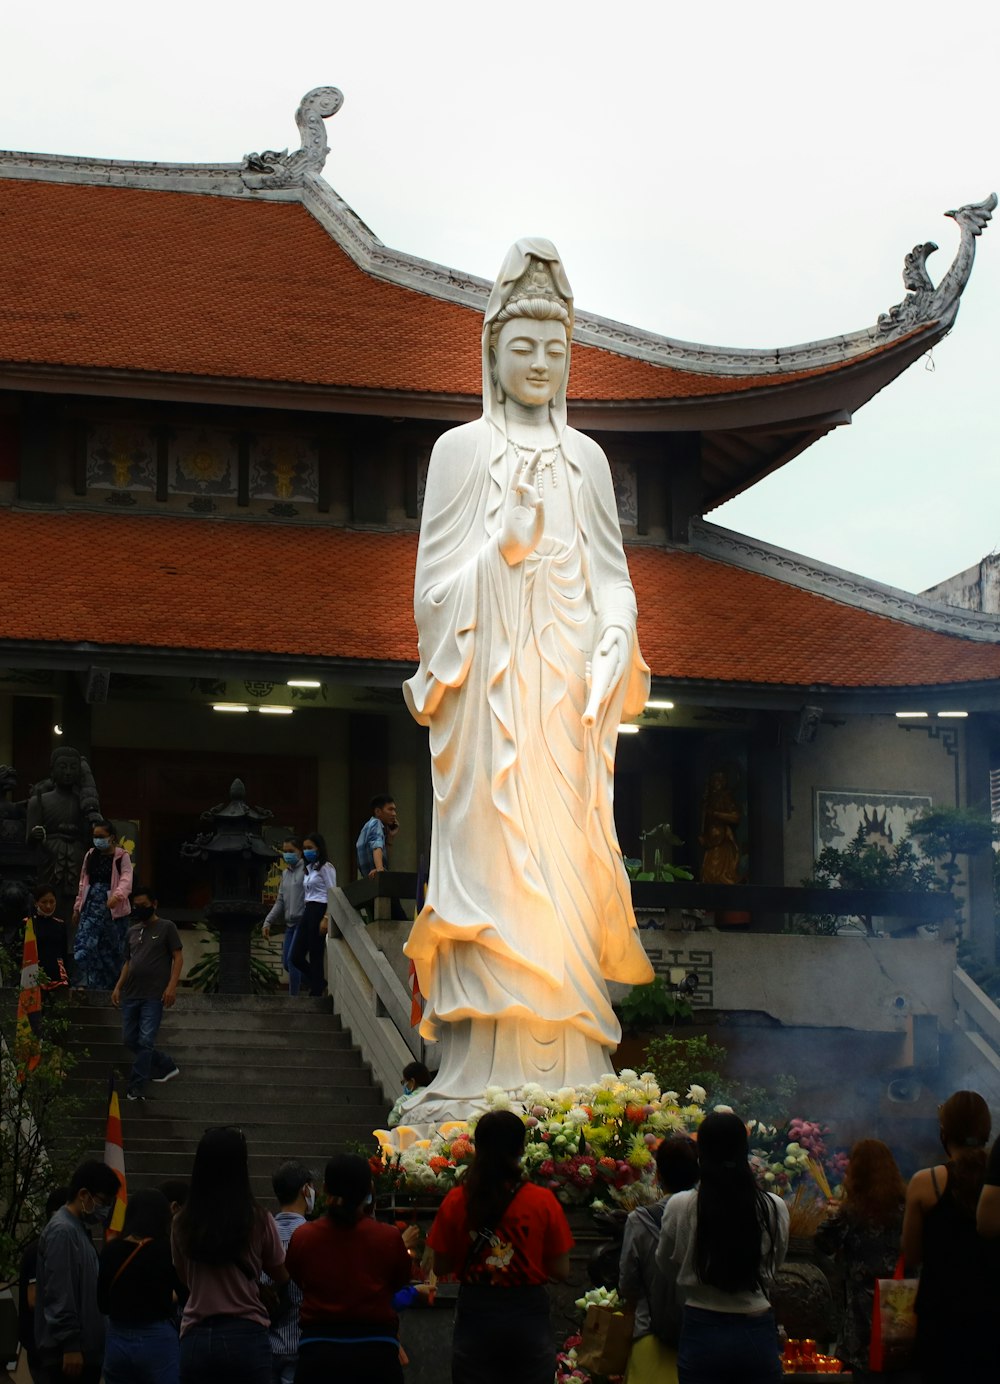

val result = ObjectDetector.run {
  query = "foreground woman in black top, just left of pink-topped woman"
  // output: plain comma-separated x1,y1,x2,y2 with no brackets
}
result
97,1190,180,1384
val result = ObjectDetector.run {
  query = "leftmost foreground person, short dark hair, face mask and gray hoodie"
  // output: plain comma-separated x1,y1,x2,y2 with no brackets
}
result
35,1160,118,1384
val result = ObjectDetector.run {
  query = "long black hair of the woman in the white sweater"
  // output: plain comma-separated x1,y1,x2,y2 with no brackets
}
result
694,1111,777,1293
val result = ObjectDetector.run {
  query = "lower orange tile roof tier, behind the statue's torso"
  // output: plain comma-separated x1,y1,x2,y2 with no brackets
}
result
0,509,1000,688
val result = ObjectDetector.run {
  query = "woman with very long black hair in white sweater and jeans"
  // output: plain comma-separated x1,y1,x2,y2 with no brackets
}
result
656,1111,788,1384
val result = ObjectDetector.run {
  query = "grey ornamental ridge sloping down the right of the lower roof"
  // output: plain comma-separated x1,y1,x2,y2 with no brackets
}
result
691,519,1000,644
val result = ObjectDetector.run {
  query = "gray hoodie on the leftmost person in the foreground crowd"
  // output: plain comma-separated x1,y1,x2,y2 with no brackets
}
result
35,1207,104,1359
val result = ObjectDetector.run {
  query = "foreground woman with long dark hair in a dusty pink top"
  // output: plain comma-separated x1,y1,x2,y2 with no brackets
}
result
172,1125,288,1384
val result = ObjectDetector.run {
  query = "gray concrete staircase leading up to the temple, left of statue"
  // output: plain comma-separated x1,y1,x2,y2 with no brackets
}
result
55,992,387,1204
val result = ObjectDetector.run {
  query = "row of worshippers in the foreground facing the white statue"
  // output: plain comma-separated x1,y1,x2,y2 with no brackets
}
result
13,1091,1000,1384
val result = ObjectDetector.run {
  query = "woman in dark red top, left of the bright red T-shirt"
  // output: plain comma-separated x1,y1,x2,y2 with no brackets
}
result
286,1153,411,1384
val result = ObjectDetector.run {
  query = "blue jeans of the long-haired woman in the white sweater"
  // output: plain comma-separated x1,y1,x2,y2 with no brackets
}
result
678,1306,781,1384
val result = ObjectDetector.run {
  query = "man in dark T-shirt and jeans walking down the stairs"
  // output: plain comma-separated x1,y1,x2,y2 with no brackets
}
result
111,884,184,1100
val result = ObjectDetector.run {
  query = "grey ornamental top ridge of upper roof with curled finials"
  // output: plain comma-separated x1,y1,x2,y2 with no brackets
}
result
0,86,997,376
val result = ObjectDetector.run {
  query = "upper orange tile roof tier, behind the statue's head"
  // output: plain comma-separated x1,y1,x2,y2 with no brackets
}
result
0,177,912,400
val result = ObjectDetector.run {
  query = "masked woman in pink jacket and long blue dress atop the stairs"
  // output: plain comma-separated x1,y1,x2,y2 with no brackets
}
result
73,818,131,990
